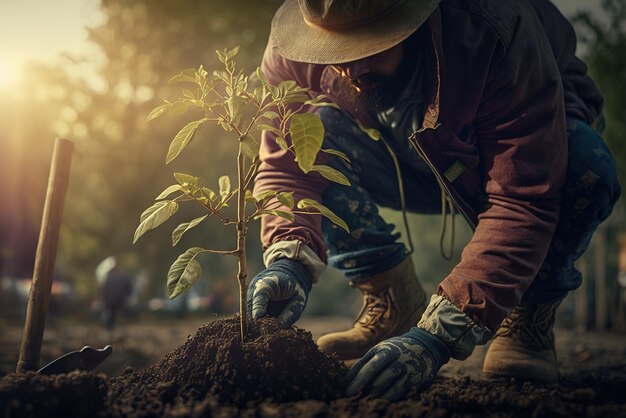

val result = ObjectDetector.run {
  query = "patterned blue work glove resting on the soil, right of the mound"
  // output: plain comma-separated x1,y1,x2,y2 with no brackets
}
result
347,327,450,401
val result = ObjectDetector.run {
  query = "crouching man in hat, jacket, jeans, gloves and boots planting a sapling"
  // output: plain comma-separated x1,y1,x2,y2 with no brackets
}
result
248,0,620,400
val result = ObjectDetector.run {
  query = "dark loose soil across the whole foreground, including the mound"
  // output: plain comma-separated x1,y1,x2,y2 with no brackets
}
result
0,318,626,418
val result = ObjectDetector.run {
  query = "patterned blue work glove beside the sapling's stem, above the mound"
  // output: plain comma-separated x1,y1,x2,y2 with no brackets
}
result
247,258,313,328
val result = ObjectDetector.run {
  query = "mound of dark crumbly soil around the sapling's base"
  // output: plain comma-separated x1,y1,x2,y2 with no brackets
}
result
127,317,347,404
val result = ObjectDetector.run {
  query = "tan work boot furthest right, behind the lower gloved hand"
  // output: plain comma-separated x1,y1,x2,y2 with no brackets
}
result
483,302,560,383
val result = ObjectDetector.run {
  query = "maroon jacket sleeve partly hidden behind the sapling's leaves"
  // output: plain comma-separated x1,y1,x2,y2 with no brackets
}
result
254,46,328,262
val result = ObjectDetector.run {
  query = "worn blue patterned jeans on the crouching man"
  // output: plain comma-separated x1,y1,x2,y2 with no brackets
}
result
320,108,620,303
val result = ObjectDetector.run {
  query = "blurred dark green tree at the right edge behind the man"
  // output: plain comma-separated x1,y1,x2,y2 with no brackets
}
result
572,0,626,329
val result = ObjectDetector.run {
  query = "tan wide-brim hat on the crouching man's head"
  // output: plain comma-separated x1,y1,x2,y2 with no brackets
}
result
269,0,440,64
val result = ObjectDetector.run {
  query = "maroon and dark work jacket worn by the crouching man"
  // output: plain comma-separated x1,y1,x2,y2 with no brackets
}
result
256,0,602,331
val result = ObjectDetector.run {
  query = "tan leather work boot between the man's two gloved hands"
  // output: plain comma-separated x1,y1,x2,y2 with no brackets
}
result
317,257,426,364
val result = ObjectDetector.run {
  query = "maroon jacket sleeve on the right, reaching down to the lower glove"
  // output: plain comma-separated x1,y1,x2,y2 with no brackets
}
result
439,8,567,331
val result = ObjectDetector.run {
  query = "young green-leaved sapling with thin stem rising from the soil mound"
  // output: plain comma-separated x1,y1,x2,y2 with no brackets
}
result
133,47,350,342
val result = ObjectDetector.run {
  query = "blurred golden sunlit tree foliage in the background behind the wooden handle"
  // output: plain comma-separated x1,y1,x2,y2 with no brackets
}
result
0,0,280,300
